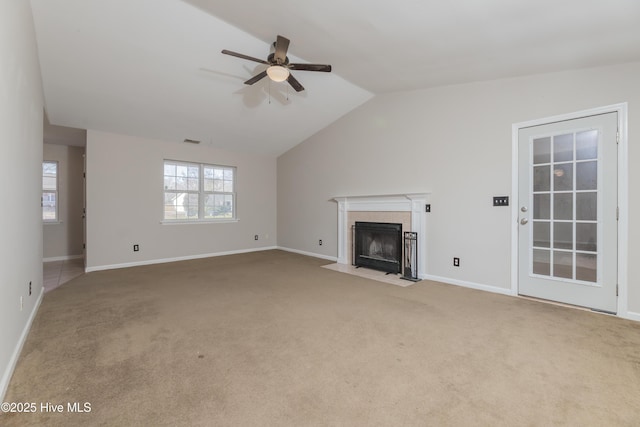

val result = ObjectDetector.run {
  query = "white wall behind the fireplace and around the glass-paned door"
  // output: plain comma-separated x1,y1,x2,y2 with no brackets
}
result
278,63,640,318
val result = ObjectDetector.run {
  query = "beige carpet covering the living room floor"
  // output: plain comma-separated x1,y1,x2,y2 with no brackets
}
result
0,251,640,426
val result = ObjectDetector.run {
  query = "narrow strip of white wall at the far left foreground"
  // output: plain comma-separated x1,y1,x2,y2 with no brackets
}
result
0,0,44,401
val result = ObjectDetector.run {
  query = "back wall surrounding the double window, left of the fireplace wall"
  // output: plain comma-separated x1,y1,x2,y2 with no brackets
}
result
86,130,277,271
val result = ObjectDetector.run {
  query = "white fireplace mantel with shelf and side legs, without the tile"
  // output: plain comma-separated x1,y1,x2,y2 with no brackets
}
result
333,193,430,278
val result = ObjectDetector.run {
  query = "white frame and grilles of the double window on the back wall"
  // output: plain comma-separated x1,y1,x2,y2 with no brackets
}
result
161,159,238,224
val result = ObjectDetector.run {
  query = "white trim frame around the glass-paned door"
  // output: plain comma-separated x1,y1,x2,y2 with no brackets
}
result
511,102,629,318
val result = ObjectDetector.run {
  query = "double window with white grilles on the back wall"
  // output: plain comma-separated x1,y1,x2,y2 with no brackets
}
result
164,160,236,221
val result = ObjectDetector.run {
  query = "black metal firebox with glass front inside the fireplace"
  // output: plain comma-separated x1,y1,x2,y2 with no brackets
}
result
353,221,402,273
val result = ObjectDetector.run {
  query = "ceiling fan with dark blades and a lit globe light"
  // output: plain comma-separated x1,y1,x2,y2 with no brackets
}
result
222,35,331,92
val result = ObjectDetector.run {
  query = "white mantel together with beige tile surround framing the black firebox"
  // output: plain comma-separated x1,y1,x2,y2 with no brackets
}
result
333,193,430,278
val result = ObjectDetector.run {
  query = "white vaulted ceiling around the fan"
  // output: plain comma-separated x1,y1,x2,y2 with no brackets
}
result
31,0,640,155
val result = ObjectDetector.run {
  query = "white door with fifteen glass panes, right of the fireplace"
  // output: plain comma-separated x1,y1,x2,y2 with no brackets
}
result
518,112,618,313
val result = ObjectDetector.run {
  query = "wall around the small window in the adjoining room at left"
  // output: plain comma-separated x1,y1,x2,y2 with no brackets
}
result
42,144,84,261
